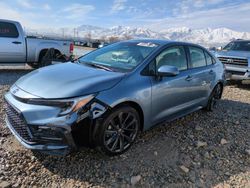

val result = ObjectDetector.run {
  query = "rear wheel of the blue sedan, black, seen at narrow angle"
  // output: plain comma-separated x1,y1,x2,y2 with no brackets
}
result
205,84,223,111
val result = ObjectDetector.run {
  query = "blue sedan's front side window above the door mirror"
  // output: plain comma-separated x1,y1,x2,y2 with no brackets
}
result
156,46,187,71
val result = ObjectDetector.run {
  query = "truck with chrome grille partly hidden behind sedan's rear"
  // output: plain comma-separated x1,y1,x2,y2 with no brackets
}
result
216,40,250,80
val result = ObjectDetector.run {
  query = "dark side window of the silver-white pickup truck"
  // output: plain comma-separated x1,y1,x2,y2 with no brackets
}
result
0,22,19,38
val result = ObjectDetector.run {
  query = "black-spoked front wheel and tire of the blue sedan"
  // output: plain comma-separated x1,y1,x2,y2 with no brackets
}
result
98,106,140,156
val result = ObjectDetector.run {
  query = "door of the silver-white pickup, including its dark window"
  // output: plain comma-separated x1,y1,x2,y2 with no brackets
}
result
0,21,26,63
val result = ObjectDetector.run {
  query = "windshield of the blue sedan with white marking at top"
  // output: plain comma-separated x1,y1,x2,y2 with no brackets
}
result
79,41,158,72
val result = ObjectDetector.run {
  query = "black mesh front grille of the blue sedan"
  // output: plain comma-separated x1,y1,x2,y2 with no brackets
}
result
6,102,33,142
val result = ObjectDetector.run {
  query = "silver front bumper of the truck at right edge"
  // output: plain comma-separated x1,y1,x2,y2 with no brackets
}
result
225,65,250,80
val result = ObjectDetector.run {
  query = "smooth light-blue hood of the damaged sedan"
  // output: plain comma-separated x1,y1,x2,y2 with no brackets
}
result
15,63,125,99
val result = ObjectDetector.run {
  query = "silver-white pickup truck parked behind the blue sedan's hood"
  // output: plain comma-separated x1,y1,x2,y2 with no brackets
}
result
0,19,74,68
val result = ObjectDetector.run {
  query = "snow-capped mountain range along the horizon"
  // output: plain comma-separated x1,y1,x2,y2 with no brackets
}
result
26,25,250,46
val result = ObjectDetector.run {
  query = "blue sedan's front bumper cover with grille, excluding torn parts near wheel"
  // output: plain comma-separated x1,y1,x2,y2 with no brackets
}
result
5,93,77,155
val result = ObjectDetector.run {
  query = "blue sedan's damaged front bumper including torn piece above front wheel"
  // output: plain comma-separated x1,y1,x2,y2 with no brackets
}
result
5,93,107,155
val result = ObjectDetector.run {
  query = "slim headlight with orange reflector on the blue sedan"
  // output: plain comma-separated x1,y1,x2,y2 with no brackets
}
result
27,95,95,115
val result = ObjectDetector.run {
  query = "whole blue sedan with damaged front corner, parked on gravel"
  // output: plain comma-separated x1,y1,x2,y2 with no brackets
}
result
5,40,224,155
